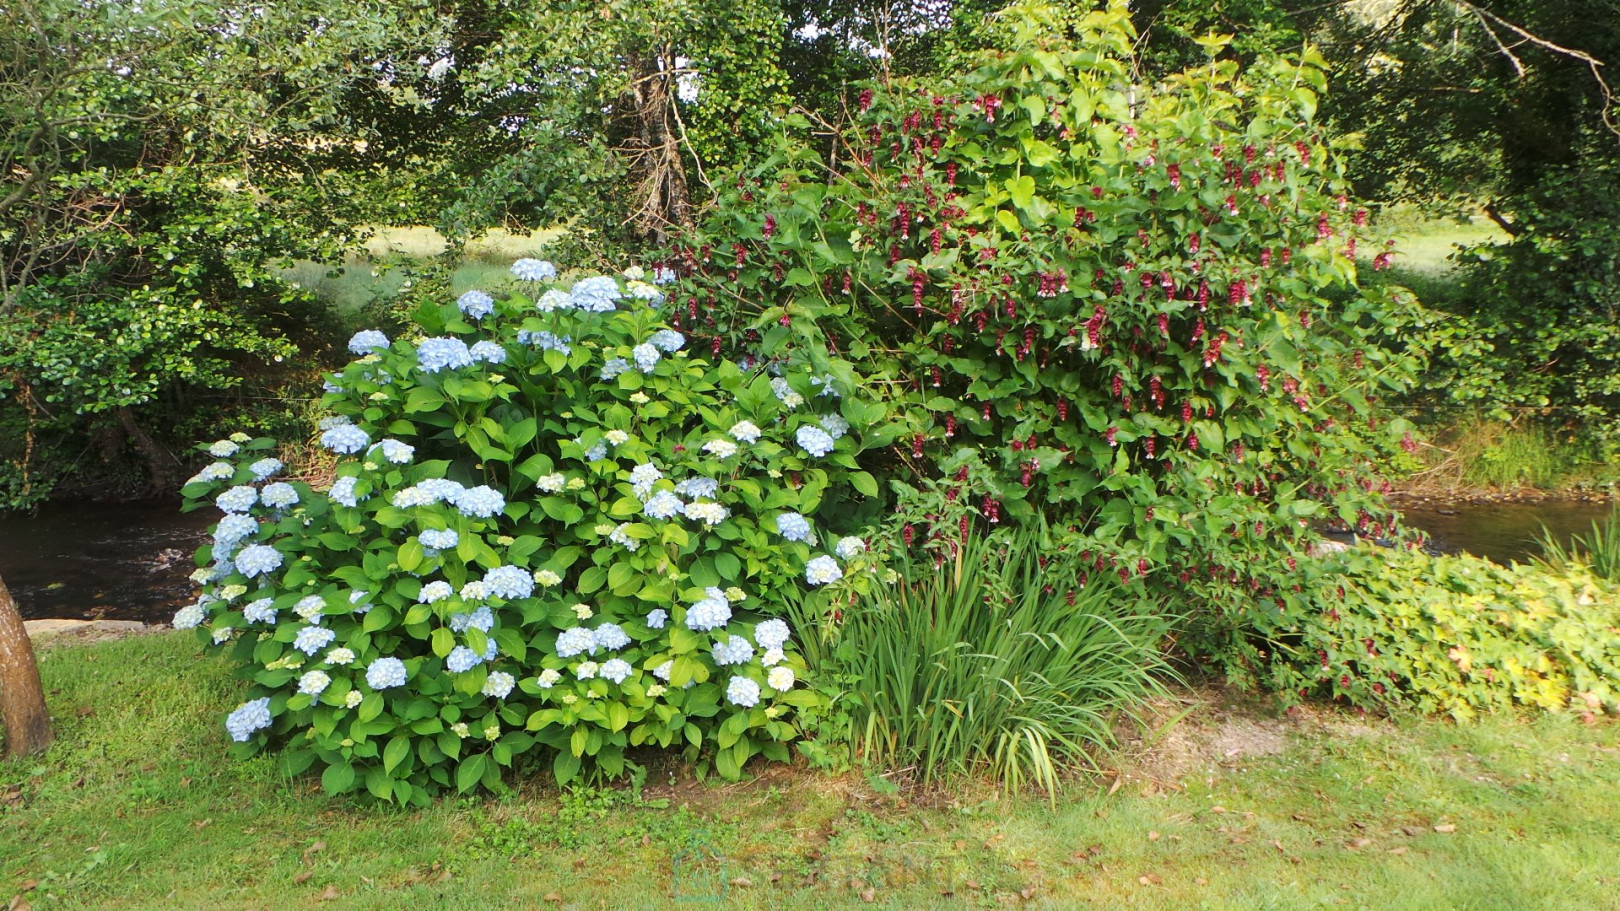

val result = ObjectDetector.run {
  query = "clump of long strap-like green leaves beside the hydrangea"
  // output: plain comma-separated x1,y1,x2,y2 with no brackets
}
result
810,528,1171,796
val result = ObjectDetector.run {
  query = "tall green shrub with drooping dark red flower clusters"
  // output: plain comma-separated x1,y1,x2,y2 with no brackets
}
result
654,6,1419,671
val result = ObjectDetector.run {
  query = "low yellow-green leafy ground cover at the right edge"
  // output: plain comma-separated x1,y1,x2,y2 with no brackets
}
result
1251,548,1620,720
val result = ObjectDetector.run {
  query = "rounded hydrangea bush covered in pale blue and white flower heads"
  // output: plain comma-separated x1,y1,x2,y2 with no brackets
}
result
175,261,881,802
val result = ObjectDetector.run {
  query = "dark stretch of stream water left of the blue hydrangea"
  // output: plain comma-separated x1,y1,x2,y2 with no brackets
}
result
0,501,219,622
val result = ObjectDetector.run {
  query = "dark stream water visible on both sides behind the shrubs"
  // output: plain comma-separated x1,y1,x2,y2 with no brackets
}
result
0,501,1610,622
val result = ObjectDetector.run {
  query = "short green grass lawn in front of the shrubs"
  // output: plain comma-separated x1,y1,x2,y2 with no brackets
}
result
0,634,1620,911
